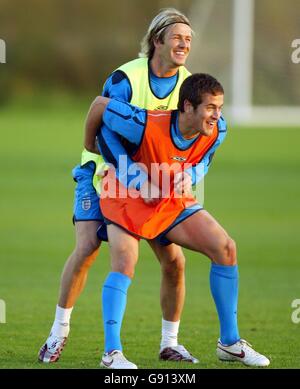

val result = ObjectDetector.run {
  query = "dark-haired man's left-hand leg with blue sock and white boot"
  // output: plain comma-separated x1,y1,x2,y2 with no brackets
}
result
100,224,138,369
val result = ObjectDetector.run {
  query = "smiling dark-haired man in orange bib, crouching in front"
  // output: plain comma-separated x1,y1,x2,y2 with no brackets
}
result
87,74,270,368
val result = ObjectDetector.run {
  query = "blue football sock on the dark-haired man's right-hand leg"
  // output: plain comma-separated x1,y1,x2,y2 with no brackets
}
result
210,263,240,345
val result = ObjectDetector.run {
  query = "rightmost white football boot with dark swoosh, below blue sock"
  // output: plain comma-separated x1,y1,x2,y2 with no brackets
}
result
217,339,270,367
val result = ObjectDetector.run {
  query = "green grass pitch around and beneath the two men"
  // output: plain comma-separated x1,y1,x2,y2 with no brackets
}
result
0,102,300,369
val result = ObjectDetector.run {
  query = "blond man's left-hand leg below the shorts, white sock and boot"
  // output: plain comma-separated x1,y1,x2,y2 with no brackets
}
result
39,221,100,363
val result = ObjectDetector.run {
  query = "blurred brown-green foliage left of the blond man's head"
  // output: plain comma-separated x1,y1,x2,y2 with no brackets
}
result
0,0,191,101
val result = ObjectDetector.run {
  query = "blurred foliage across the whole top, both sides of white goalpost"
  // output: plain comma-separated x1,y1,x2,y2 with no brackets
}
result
0,0,300,105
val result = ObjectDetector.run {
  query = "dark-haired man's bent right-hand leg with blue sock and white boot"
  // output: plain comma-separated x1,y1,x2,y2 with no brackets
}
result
166,210,269,366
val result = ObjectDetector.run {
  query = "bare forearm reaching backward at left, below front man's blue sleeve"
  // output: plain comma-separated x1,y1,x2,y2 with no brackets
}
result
84,96,110,154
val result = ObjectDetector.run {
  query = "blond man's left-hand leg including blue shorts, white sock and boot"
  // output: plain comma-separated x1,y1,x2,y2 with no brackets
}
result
38,161,102,363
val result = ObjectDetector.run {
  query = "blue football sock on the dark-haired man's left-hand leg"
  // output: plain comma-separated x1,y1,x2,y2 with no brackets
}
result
102,273,131,352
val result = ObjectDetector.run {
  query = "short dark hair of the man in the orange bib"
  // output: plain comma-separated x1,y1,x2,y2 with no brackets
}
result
178,73,224,112
